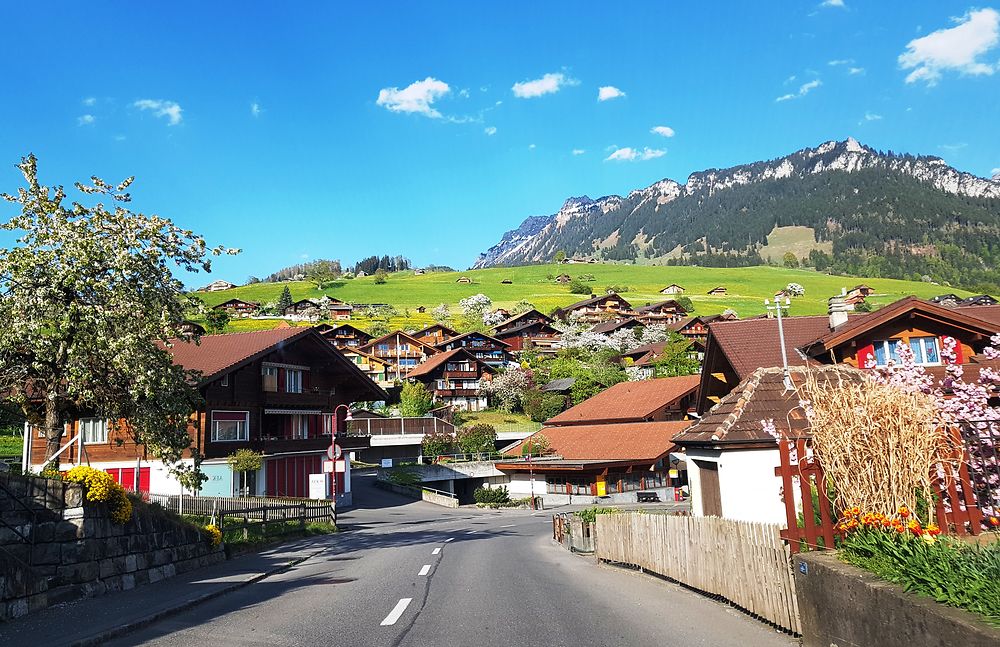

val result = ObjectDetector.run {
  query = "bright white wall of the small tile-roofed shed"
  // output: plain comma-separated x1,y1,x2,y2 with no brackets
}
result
687,447,786,524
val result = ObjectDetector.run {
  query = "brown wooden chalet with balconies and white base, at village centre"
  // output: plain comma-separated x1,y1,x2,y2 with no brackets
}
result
407,348,496,411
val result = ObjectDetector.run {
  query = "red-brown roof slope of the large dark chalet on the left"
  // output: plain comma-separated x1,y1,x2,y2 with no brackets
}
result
168,327,312,378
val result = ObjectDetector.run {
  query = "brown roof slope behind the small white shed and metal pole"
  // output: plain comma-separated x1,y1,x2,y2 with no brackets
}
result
708,315,832,380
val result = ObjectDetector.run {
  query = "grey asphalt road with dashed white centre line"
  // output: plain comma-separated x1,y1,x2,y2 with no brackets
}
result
109,476,797,647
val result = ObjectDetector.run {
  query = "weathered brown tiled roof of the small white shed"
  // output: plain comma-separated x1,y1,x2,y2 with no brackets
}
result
674,365,863,446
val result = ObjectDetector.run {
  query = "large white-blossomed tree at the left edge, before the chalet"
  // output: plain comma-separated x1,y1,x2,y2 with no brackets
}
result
0,156,238,487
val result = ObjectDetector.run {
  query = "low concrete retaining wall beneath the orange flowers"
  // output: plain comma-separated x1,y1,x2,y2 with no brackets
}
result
795,551,1000,647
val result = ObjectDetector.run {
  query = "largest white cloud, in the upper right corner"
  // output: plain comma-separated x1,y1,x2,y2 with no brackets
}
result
899,9,1000,85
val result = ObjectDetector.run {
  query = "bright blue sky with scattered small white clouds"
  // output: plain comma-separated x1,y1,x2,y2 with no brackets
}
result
0,0,1000,283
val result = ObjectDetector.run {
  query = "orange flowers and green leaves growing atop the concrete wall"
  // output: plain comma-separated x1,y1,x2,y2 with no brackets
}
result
837,507,1000,625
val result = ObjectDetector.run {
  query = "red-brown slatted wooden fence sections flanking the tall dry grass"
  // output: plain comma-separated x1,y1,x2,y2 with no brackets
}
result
774,431,984,553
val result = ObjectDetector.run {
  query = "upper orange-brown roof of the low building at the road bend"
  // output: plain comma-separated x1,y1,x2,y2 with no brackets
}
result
545,375,701,425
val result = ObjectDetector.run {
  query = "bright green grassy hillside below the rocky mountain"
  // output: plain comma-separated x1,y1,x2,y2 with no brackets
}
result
198,264,969,330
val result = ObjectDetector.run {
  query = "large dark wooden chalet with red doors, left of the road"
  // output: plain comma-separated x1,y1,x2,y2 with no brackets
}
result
25,327,387,500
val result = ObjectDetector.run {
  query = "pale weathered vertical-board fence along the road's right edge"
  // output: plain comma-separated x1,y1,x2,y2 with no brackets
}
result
596,513,801,634
